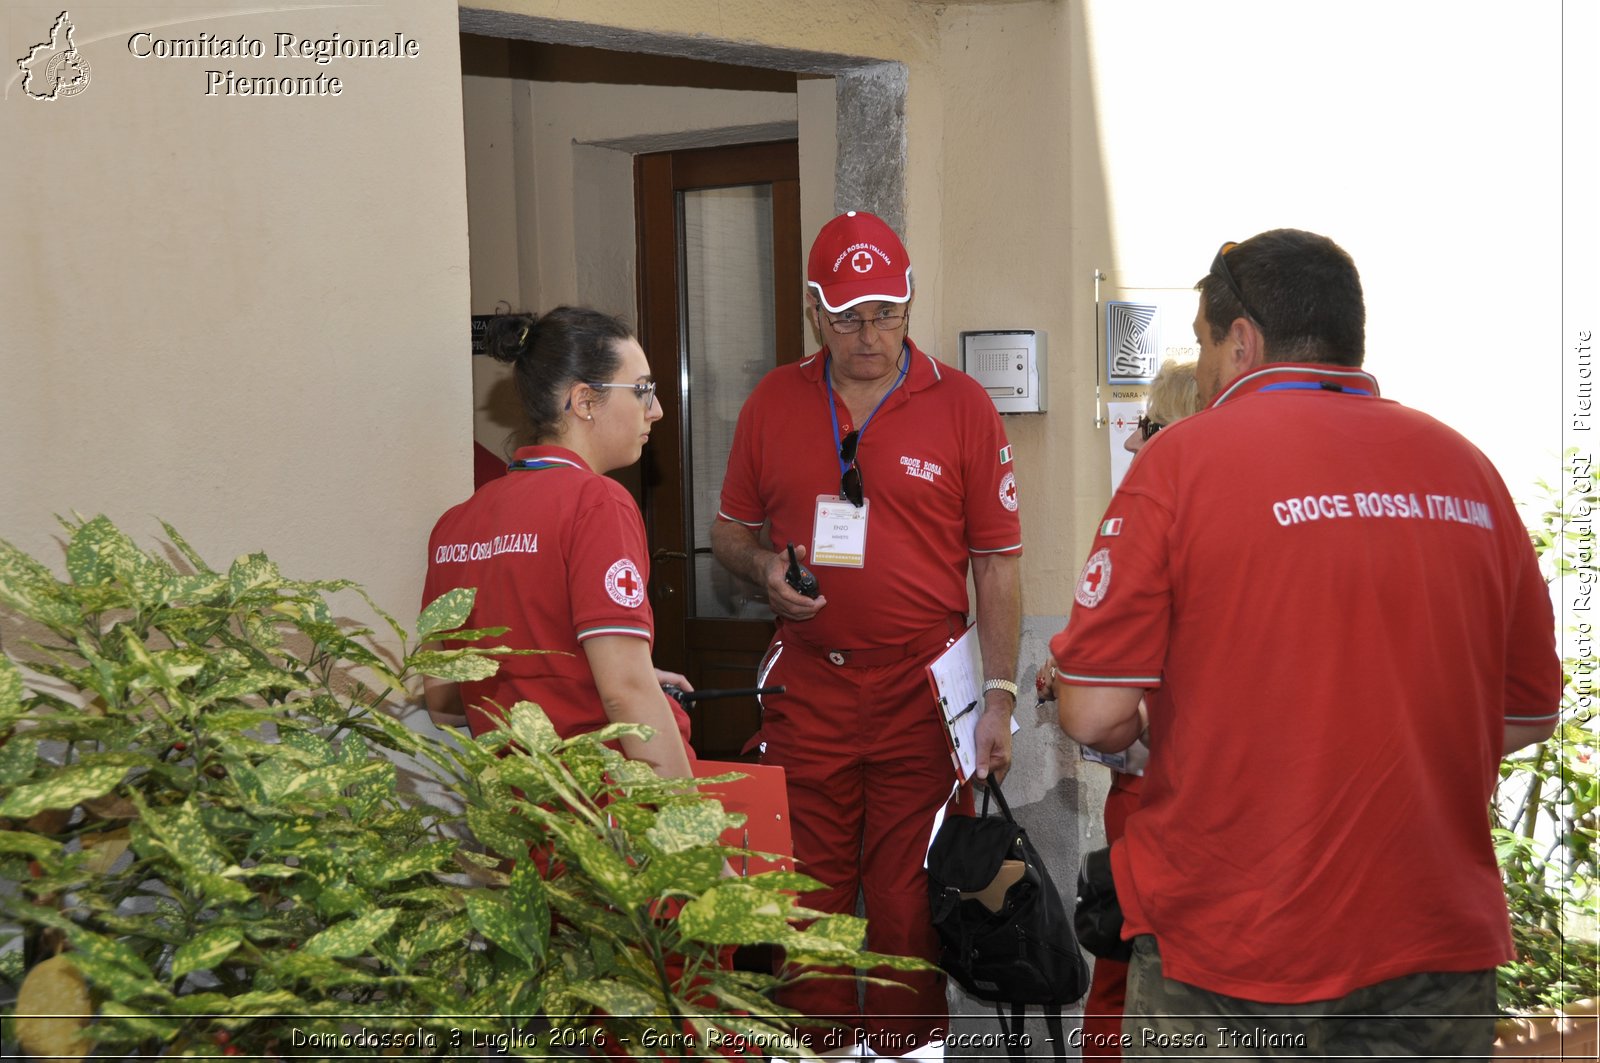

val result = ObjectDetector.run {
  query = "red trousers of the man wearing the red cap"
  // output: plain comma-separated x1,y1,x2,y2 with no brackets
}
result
762,640,971,1055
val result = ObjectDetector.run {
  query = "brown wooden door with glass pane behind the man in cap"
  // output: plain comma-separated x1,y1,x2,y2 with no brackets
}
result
634,141,805,759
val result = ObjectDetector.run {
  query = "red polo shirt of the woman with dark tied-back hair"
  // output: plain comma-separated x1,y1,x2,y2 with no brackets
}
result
422,447,688,744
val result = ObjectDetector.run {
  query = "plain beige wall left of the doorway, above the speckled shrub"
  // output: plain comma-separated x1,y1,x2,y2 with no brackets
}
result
0,0,470,618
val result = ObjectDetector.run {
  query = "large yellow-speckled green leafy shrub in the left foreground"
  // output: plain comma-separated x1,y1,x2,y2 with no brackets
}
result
0,517,922,1058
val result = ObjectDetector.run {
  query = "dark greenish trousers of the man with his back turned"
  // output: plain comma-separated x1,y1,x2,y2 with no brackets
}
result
1122,935,1494,1061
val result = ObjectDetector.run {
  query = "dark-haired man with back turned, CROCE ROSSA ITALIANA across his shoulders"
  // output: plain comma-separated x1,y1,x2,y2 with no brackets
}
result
1051,229,1562,1057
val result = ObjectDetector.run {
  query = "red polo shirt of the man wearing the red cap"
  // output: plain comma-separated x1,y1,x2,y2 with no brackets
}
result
718,341,1022,648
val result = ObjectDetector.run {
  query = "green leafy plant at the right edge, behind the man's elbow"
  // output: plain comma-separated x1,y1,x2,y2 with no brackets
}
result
1494,450,1600,1012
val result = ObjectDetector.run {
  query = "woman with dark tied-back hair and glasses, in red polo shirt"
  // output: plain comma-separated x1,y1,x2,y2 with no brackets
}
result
422,306,693,778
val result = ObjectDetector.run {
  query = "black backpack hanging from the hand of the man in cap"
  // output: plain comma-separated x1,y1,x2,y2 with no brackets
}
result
928,778,1090,1058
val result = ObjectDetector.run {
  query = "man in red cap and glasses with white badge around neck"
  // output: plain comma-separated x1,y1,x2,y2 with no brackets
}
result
712,211,1022,1055
